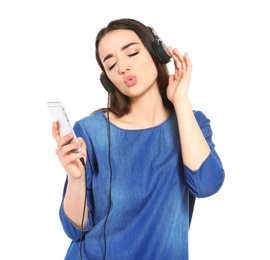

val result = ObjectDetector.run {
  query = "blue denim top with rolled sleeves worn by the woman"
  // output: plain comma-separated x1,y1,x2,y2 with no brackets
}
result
60,108,224,260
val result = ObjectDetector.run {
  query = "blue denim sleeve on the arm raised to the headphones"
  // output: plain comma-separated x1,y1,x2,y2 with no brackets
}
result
184,111,225,198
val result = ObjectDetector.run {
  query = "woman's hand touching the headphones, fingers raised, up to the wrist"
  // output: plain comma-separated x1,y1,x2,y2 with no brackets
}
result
167,47,192,105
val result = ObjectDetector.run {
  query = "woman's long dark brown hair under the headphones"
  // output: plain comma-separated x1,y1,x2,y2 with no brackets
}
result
95,18,173,117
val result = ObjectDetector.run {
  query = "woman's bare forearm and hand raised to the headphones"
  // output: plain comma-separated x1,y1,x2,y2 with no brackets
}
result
167,47,210,170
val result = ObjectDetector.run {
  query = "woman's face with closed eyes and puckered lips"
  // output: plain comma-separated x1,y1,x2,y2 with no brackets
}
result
98,29,157,98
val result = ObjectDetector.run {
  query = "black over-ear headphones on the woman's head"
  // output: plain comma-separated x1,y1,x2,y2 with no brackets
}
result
99,27,171,93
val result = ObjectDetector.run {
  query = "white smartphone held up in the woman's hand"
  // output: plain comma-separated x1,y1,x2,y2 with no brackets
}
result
47,101,81,152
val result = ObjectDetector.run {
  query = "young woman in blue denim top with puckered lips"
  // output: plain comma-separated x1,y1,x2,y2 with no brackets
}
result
52,19,224,260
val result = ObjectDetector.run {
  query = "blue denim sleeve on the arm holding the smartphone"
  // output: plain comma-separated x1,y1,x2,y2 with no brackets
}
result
59,122,93,241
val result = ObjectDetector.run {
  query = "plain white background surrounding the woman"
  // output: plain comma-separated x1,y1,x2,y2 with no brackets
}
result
0,0,270,260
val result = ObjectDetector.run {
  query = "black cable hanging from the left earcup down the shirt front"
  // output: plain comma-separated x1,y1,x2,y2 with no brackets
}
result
104,95,112,260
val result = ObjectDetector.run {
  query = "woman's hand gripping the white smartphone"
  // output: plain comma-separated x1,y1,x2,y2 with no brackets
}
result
52,122,86,180
